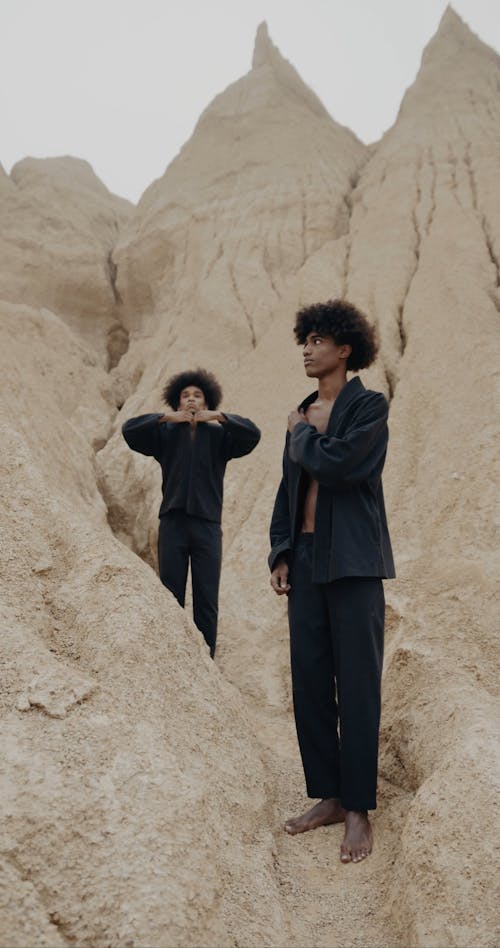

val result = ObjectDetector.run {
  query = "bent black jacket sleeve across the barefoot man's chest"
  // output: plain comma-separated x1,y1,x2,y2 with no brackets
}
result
290,392,388,489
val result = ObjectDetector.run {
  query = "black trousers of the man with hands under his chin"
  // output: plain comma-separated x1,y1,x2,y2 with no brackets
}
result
158,510,222,658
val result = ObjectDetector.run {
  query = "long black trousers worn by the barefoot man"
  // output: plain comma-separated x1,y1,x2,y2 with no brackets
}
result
288,533,384,810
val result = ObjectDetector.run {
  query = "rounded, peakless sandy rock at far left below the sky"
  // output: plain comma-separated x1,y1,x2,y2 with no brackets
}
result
0,158,131,364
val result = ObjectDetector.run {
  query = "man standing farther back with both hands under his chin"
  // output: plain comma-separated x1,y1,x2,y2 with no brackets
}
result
122,369,260,658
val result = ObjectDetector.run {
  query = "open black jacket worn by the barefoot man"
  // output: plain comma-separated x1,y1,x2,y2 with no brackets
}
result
269,376,395,583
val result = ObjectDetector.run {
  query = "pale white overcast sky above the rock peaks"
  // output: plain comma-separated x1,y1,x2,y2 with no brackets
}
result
0,0,500,202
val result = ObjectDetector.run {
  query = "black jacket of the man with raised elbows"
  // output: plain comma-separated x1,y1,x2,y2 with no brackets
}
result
122,413,260,523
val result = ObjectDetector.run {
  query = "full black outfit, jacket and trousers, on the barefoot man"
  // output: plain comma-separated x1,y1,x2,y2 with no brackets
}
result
269,376,394,810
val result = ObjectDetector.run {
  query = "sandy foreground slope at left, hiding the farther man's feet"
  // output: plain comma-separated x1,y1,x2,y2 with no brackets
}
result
0,303,288,948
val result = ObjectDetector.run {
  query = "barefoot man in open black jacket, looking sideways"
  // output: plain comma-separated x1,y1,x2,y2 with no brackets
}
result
269,300,394,862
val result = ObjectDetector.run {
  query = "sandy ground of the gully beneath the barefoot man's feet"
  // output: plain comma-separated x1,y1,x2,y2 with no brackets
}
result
221,659,410,948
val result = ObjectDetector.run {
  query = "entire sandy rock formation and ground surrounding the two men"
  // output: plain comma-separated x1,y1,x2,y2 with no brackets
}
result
0,9,500,948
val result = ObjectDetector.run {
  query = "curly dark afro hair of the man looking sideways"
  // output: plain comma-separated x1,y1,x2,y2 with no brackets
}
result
294,300,378,372
